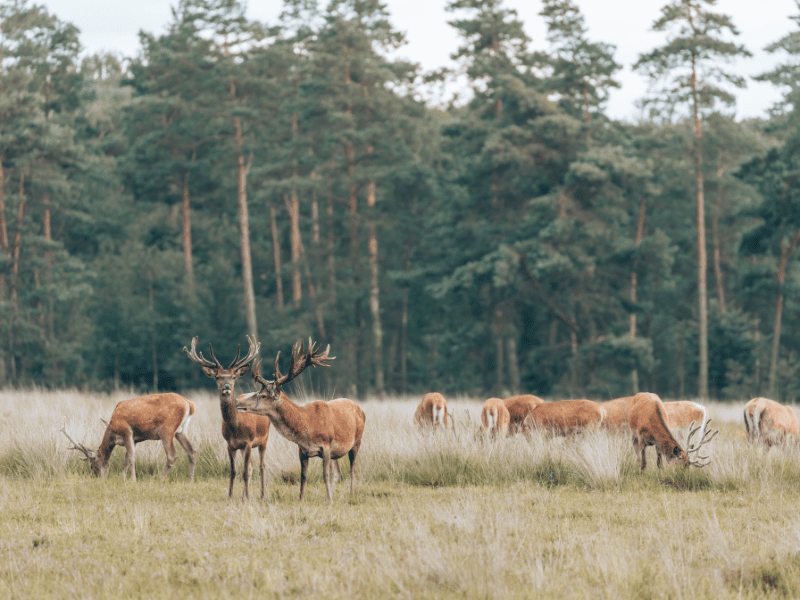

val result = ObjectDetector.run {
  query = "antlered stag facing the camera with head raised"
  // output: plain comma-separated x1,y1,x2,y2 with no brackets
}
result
183,336,269,501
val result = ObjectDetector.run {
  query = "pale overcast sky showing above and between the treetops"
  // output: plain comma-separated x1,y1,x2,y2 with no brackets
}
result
34,0,800,120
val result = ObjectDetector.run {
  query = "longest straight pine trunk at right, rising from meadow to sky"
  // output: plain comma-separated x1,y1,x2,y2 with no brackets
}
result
691,57,708,400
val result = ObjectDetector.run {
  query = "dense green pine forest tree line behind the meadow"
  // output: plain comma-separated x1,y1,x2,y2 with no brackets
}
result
0,0,800,401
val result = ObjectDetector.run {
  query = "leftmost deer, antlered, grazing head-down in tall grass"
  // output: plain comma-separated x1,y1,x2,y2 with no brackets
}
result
61,393,195,481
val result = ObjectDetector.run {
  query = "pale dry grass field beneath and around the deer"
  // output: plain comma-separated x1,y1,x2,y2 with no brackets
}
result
0,391,800,599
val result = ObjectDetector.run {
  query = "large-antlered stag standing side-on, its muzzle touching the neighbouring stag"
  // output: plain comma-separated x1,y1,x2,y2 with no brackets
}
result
237,338,365,502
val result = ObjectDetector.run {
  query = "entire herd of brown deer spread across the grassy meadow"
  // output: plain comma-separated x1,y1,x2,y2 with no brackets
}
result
61,336,798,502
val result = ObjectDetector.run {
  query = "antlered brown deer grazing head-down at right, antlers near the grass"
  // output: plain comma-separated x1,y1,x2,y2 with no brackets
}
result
627,392,719,470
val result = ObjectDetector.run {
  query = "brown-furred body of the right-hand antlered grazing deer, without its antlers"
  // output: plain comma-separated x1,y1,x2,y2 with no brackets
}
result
627,392,688,470
